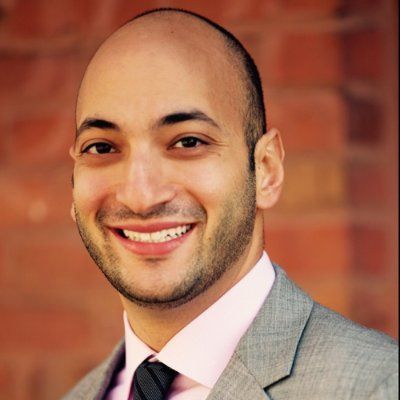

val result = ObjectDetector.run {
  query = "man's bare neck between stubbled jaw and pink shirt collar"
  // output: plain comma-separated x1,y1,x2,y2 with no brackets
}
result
120,218,263,352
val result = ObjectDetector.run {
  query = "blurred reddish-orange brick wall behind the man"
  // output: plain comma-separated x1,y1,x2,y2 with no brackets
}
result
0,0,398,400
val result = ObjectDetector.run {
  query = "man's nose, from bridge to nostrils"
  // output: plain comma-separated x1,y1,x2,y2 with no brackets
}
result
116,151,176,215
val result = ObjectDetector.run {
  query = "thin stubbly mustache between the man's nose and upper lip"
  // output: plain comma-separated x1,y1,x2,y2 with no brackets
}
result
96,204,207,225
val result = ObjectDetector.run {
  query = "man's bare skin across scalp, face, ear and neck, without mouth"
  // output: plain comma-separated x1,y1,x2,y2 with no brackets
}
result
71,14,284,351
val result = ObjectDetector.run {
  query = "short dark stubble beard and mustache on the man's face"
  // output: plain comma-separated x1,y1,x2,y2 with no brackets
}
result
75,172,256,309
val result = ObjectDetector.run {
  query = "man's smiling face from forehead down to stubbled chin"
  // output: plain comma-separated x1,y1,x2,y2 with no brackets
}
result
72,27,256,307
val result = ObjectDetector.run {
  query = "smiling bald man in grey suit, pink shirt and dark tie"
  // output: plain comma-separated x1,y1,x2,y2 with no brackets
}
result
62,9,397,400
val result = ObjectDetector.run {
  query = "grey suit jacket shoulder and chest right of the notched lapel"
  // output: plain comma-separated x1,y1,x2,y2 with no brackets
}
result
269,303,398,400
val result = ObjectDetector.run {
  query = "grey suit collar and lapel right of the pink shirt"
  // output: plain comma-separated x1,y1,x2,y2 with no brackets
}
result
207,265,313,400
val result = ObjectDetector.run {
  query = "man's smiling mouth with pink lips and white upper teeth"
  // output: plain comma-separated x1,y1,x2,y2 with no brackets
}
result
111,223,195,256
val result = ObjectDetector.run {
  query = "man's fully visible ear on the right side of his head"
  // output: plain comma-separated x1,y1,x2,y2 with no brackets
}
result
254,128,285,210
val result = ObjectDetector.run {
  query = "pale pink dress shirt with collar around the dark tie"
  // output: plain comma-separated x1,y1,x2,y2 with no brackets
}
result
107,253,275,400
